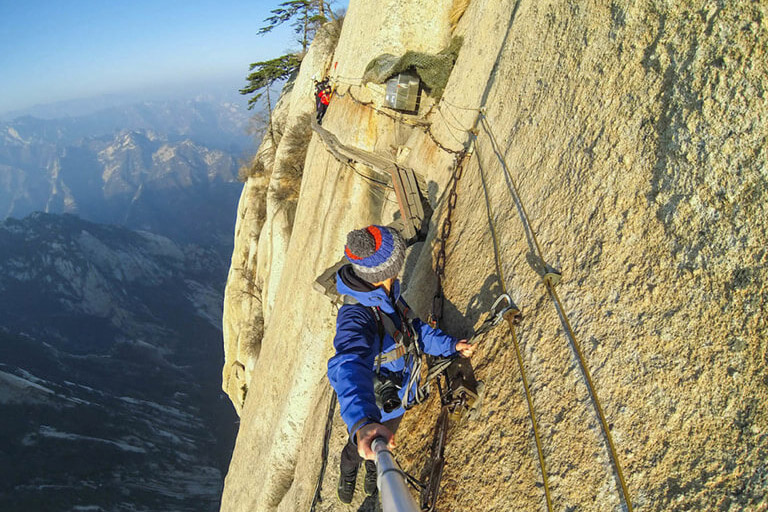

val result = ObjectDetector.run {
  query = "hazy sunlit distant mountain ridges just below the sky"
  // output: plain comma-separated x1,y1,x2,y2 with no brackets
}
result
0,100,252,251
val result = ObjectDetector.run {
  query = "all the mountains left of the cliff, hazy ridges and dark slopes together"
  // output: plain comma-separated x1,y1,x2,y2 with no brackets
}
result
0,95,252,512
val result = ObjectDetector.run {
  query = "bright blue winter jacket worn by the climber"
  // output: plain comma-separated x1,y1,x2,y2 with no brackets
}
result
328,266,458,439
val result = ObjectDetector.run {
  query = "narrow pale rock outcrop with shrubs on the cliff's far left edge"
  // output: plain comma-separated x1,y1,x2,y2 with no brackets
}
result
223,24,339,412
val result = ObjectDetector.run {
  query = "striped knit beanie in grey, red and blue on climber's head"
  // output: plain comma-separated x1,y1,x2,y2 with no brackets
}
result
344,226,405,283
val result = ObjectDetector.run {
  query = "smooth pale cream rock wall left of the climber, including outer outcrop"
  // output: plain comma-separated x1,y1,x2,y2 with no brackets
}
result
222,0,448,511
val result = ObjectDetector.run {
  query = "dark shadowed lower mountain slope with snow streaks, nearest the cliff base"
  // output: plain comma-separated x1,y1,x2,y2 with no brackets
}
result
0,213,235,512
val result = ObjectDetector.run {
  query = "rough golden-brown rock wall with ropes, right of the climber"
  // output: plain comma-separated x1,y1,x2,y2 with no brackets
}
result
390,2,768,510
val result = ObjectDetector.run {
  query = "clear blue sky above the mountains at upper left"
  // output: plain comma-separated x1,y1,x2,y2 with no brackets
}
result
0,0,340,113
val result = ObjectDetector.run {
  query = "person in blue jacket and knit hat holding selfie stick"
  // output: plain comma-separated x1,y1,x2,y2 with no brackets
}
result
328,226,474,503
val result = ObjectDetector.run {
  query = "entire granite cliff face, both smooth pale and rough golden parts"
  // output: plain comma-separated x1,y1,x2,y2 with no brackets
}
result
222,0,768,512
